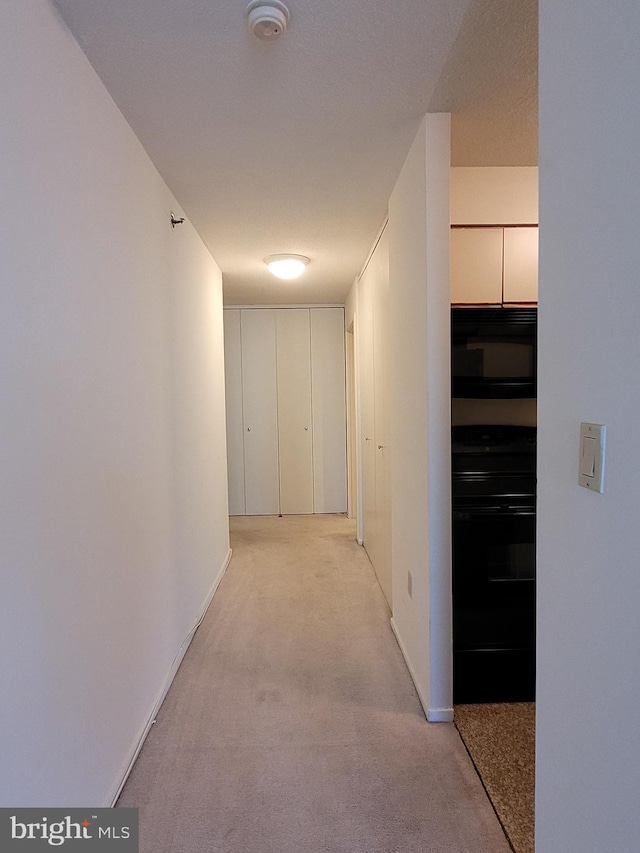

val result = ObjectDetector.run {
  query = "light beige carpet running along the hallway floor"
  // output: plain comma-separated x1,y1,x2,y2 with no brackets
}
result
118,516,509,853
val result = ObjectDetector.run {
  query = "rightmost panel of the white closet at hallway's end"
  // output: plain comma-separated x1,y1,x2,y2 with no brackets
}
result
311,308,347,512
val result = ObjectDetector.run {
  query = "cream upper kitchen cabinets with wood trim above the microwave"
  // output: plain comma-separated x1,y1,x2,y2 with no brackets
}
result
451,226,538,305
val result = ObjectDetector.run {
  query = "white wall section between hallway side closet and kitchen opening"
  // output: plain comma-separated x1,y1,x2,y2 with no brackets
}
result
388,113,453,722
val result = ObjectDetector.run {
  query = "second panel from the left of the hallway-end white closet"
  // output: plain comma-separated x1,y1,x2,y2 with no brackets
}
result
240,309,280,515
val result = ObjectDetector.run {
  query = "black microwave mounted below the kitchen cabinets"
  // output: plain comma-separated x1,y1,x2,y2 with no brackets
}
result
451,308,538,399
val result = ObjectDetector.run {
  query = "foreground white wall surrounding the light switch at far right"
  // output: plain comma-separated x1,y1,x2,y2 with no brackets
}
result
536,0,640,853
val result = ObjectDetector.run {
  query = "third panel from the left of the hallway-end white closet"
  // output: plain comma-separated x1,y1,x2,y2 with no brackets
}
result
276,308,313,515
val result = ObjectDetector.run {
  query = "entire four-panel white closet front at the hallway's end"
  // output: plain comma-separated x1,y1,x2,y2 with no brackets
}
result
224,308,347,515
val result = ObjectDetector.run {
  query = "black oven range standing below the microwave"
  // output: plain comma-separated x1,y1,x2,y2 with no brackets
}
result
452,425,536,703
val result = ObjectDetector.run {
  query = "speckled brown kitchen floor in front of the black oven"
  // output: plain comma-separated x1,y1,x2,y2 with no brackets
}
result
454,702,536,853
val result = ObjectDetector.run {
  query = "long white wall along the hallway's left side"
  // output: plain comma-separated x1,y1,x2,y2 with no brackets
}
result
0,0,229,806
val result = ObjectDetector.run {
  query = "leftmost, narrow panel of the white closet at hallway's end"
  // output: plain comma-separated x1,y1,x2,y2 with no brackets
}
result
224,309,245,515
